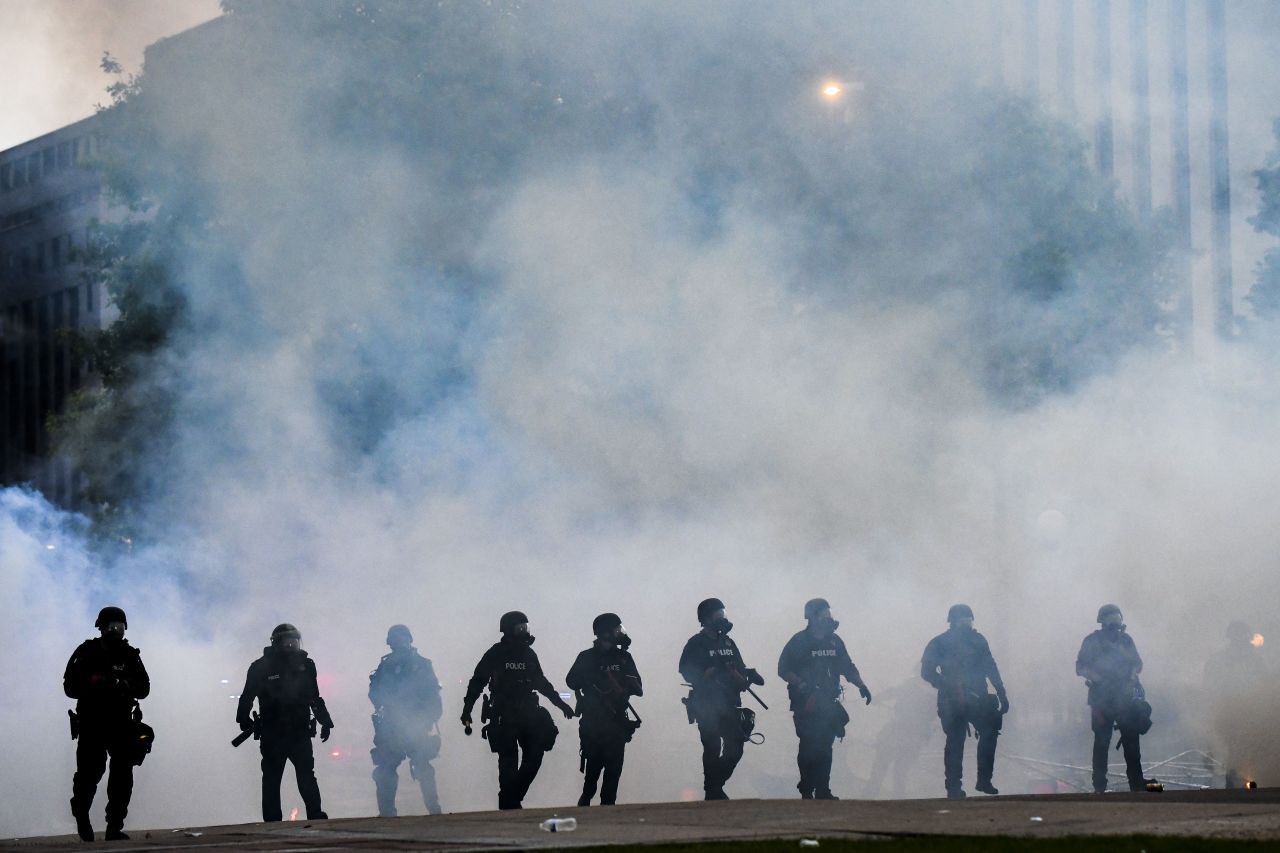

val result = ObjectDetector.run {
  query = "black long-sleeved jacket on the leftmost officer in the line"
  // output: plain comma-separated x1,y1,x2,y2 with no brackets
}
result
63,637,151,726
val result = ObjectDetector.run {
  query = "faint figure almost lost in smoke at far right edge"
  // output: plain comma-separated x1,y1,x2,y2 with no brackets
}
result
1204,619,1275,788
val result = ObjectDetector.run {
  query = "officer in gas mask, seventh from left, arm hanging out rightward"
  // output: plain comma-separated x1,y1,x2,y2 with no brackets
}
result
778,598,872,799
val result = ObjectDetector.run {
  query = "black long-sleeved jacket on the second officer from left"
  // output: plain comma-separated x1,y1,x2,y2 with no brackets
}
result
236,646,333,734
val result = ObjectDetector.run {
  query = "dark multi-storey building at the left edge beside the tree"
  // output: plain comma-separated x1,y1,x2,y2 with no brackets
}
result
0,117,106,506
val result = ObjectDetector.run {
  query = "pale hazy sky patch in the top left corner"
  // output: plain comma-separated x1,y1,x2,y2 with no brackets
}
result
0,0,219,151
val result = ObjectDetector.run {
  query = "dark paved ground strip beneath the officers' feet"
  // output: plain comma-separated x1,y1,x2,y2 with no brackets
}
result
10,788,1280,853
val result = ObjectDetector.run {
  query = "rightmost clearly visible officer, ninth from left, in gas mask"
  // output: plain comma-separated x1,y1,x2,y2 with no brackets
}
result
1075,605,1151,794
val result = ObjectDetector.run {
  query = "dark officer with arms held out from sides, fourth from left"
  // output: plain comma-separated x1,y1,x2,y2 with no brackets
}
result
462,611,573,809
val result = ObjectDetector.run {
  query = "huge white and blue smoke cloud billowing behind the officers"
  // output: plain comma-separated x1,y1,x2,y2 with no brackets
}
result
0,3,1280,835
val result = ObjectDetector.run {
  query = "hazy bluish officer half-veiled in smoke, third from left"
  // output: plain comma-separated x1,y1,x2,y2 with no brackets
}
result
369,625,443,817
